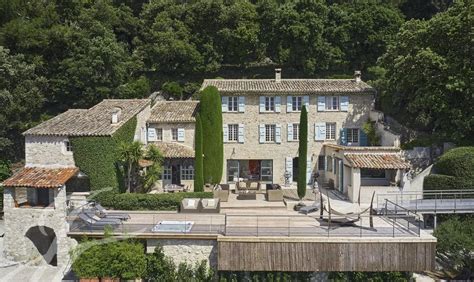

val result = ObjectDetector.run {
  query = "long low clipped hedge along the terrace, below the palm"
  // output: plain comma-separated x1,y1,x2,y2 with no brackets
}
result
91,191,213,211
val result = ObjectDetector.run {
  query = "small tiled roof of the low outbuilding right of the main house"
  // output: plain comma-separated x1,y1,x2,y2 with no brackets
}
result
344,153,411,169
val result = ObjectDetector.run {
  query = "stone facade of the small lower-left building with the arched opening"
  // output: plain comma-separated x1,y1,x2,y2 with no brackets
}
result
4,186,77,267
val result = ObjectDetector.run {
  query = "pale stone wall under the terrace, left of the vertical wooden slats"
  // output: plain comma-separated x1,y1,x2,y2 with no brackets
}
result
146,239,217,268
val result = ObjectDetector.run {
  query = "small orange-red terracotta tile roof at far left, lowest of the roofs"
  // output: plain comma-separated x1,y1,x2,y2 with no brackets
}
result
3,167,79,188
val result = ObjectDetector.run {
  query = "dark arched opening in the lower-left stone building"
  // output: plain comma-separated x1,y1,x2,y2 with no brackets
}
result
25,226,58,266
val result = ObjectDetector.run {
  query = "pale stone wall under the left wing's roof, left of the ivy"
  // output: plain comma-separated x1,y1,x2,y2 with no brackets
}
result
25,135,75,167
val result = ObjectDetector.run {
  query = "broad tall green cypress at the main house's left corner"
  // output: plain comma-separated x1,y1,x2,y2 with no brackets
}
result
200,86,224,184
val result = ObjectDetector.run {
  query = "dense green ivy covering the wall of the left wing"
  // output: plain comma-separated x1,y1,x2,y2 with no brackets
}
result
70,117,137,191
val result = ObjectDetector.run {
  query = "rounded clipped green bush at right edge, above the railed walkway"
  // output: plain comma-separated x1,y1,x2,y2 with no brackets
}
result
434,147,474,178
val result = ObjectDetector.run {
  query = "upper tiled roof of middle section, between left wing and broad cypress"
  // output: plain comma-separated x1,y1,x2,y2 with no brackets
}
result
148,101,199,123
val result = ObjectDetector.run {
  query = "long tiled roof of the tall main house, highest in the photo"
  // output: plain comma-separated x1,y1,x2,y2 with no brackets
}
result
201,79,375,94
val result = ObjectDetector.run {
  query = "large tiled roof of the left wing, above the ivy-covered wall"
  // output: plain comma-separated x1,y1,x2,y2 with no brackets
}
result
23,99,150,136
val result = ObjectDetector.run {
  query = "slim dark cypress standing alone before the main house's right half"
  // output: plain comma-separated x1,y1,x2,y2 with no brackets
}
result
298,106,308,201
